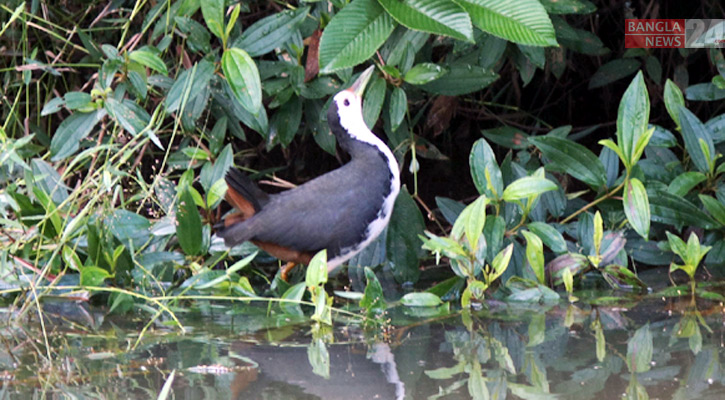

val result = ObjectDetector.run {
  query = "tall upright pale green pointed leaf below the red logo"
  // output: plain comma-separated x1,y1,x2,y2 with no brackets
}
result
617,71,649,168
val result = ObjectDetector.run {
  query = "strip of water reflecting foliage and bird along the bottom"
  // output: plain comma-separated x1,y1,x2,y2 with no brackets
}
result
0,299,725,400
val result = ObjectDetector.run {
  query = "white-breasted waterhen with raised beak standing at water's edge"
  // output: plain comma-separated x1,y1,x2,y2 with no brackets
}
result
218,67,400,279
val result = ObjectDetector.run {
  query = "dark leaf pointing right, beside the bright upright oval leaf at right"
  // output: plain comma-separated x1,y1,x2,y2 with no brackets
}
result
647,189,717,229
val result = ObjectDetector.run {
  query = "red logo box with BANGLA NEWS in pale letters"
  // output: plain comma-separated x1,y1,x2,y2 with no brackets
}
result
624,19,685,49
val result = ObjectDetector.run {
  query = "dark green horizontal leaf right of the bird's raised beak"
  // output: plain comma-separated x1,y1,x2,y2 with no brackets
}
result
418,64,499,96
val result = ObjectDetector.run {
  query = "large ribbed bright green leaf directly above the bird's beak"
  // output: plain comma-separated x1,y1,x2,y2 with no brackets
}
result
319,0,395,73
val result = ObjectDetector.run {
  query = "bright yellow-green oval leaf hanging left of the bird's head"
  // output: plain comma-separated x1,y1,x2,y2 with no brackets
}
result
222,48,262,115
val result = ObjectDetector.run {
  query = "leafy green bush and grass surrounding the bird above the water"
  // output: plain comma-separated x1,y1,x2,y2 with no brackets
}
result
0,0,725,321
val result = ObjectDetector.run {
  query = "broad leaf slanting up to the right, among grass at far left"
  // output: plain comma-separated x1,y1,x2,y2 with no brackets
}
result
50,110,106,161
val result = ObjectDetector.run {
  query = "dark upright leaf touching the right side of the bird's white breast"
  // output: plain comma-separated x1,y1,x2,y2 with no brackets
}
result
385,188,425,283
